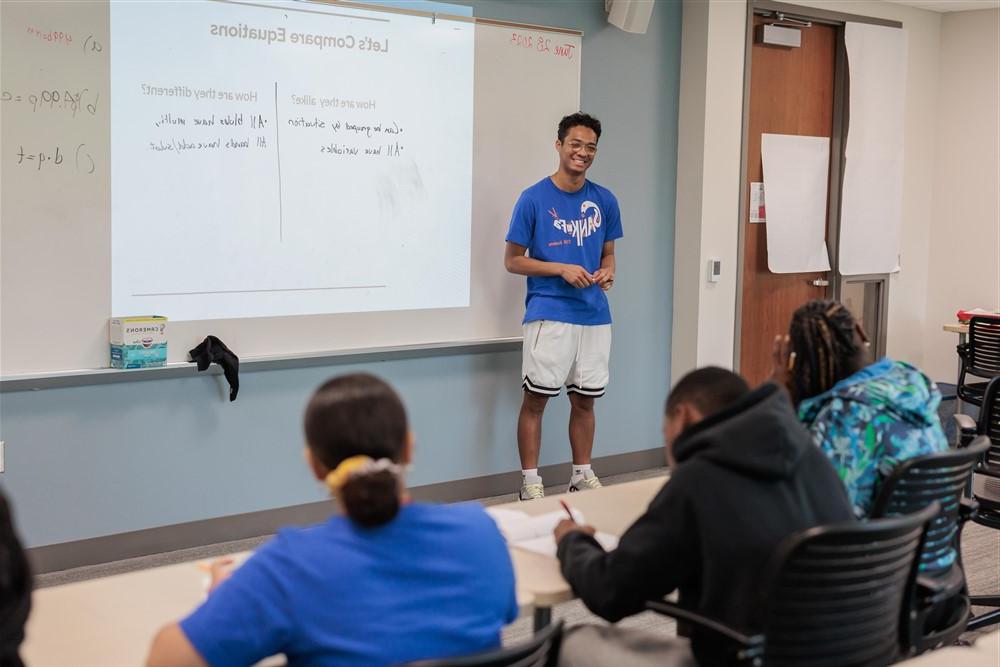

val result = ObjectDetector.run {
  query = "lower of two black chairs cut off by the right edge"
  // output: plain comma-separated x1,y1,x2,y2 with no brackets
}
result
955,377,1000,630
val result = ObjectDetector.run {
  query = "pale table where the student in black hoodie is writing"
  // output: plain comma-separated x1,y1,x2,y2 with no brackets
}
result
495,476,666,629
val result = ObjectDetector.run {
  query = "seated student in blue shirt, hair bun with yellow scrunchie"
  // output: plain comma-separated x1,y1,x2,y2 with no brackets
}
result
154,374,517,667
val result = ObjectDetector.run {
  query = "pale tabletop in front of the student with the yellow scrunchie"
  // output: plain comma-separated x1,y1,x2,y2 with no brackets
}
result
21,552,533,667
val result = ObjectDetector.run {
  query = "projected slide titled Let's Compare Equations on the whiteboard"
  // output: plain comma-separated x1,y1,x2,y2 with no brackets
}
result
110,1,474,320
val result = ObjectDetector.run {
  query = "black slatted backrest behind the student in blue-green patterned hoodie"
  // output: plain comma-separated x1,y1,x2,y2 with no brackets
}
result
871,442,989,577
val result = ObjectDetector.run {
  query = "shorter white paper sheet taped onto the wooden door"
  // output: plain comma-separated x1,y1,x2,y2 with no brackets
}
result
761,134,830,273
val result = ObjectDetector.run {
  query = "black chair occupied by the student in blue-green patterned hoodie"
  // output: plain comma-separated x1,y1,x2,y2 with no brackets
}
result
871,438,990,653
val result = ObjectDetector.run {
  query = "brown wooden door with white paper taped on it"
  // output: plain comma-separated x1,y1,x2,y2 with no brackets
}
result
739,16,840,385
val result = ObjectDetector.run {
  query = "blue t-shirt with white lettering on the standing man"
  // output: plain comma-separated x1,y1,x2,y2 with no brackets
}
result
507,176,622,324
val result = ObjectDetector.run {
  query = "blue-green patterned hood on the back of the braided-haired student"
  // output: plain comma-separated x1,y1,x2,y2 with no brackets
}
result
799,358,941,428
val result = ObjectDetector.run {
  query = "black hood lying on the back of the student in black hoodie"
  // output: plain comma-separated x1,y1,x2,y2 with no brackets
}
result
673,383,814,479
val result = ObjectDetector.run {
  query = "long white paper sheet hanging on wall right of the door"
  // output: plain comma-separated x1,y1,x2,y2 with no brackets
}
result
840,23,907,276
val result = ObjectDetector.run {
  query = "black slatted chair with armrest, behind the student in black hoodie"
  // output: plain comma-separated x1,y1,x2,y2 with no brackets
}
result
647,503,940,667
